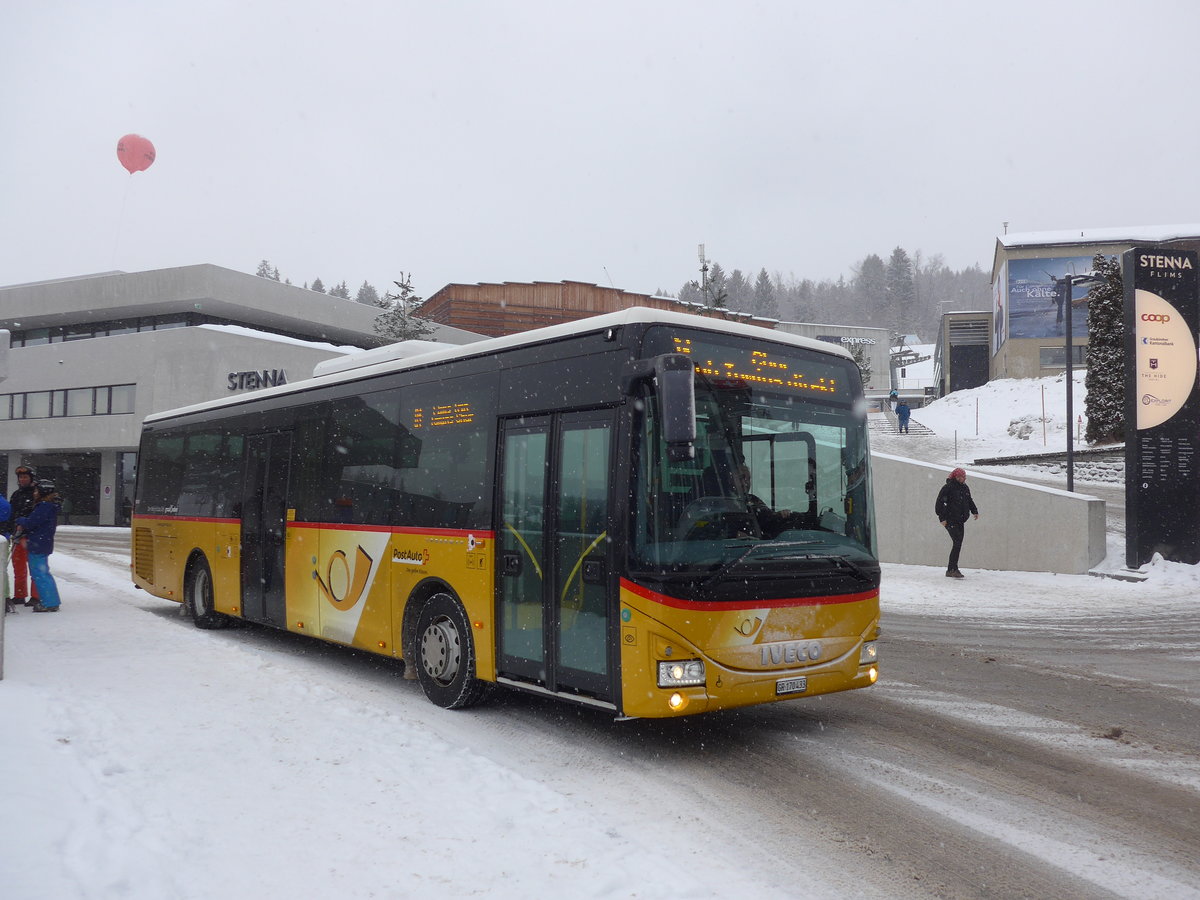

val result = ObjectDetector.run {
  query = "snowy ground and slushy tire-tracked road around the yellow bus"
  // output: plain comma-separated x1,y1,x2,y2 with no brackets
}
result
0,528,1200,900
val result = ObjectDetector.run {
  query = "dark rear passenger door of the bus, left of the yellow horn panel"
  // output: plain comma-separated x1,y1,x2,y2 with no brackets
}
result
241,432,292,628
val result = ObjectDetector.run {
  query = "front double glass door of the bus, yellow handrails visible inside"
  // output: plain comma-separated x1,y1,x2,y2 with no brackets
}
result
497,412,613,700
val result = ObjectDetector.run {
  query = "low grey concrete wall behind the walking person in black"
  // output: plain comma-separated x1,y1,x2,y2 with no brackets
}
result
871,454,1106,575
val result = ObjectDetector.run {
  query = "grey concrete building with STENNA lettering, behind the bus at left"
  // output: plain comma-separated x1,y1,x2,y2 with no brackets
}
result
0,265,481,524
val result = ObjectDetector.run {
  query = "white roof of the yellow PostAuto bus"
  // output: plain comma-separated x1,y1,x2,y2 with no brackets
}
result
145,306,853,422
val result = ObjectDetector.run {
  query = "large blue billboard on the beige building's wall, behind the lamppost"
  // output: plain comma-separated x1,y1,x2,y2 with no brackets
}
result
1008,257,1092,340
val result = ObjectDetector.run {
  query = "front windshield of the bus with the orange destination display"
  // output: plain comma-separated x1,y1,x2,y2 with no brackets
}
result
632,329,877,577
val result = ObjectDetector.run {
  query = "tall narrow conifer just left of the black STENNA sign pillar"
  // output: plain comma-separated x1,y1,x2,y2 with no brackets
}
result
1084,253,1126,444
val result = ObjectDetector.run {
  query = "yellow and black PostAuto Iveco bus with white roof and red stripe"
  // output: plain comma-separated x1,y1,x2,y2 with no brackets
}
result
132,308,880,718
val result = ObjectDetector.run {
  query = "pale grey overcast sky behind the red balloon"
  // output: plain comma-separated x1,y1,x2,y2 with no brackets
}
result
0,0,1200,303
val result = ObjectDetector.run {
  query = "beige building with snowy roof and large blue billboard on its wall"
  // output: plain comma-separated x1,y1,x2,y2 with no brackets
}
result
984,224,1200,378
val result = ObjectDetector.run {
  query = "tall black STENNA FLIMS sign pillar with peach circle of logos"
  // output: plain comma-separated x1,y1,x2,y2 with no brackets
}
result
1121,247,1200,568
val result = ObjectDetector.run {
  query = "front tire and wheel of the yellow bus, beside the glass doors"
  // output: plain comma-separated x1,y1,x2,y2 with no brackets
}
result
413,592,488,709
